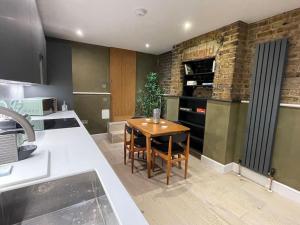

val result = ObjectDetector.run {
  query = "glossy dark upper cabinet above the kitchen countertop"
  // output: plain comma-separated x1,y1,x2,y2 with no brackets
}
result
0,0,47,84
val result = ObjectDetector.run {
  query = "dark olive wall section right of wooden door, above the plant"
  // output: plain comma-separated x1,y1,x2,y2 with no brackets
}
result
136,52,158,98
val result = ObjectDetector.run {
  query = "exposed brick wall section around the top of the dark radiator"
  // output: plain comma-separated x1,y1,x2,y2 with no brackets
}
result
241,8,300,103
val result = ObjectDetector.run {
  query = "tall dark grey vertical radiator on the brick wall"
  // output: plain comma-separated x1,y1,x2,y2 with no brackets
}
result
242,39,288,175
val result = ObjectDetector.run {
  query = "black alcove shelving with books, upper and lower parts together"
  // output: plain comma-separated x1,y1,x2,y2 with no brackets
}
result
178,57,211,155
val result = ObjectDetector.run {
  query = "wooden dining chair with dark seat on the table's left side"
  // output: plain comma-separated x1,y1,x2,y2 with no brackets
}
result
124,124,146,173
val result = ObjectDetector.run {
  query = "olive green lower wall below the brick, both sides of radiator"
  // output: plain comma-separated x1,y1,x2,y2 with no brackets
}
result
203,101,300,190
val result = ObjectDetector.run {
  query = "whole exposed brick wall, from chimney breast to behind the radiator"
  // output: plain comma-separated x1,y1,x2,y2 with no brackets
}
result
159,9,300,103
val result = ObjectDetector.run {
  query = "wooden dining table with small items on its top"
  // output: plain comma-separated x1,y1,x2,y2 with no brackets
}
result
127,118,190,178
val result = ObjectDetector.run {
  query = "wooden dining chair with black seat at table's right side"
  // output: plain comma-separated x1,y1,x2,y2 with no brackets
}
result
152,133,190,185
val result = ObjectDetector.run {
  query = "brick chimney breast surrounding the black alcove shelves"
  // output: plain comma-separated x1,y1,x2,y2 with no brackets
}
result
160,21,246,100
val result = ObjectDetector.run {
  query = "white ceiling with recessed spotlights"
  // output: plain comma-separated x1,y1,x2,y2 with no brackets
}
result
38,0,300,54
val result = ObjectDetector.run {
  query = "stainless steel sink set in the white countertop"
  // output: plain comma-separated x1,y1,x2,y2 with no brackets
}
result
0,172,118,225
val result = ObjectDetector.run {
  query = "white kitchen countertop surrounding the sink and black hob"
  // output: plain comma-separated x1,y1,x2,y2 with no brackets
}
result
0,111,148,225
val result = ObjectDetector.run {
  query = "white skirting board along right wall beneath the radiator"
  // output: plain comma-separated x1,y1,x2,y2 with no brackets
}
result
201,155,300,203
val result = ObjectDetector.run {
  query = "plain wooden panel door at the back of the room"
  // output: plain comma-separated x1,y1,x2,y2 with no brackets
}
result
110,48,136,121
